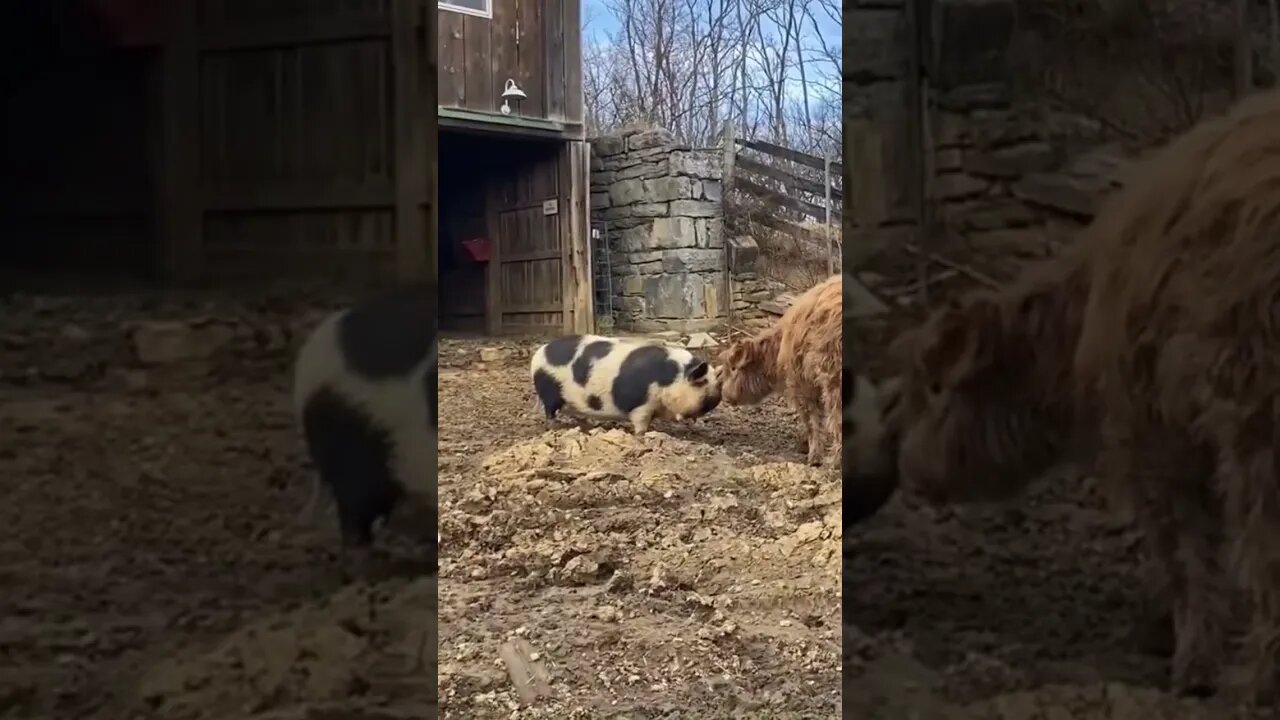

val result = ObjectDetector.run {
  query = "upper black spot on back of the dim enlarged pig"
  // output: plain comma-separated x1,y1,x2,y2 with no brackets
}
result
338,284,436,380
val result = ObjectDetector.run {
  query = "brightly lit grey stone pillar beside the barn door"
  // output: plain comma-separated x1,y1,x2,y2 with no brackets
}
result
591,126,726,332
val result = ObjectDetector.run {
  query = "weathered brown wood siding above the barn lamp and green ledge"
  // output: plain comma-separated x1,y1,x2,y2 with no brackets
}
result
438,0,582,124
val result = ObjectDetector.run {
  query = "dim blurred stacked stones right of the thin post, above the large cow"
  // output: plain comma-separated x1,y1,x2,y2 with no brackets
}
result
928,0,1125,263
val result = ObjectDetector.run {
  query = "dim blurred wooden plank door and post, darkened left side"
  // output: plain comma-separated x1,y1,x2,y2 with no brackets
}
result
184,0,434,282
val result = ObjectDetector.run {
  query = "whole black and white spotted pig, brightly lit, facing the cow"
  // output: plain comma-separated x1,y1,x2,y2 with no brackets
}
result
529,334,721,434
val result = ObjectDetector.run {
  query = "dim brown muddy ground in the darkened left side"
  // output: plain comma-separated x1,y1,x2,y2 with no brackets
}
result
0,286,436,720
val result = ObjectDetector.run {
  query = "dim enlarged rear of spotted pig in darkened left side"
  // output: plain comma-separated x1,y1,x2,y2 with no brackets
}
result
293,283,439,568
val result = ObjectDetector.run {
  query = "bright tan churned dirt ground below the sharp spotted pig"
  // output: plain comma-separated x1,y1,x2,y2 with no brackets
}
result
440,341,841,719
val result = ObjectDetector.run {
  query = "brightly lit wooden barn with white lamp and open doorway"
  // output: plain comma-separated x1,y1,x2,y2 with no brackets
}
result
436,0,594,334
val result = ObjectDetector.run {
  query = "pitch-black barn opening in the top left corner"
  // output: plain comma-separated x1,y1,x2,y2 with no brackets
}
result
0,1,160,279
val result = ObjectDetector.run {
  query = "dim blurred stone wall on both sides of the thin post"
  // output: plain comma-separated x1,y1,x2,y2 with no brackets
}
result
844,0,1126,266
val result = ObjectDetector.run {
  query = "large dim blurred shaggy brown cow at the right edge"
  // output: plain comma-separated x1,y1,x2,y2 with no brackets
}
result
897,92,1280,702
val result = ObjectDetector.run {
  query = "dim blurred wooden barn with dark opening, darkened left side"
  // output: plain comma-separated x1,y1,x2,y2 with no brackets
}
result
0,0,436,286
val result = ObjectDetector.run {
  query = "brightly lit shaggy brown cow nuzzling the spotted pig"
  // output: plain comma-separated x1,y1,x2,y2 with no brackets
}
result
721,275,844,465
